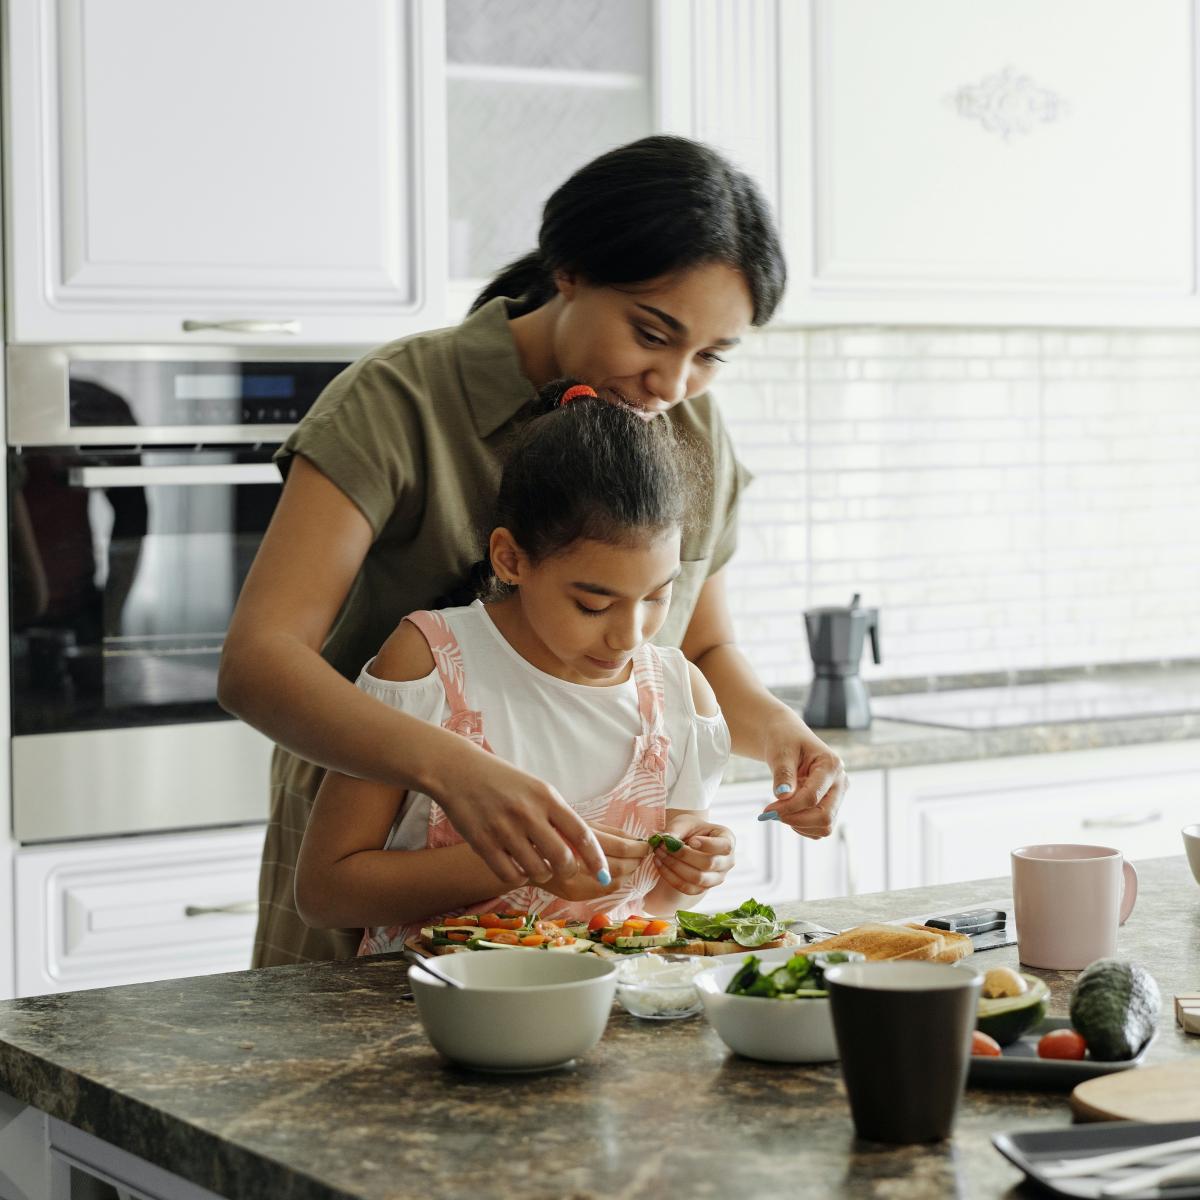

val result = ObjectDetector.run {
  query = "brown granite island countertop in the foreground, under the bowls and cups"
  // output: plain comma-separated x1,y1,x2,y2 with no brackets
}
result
0,857,1200,1200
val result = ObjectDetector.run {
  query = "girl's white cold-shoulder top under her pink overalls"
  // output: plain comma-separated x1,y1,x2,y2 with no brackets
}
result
358,600,730,850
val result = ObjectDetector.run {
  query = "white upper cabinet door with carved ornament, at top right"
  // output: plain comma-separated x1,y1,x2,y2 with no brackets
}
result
780,0,1200,324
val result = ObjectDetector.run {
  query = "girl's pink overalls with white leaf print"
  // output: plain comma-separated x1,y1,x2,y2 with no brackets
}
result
359,612,671,954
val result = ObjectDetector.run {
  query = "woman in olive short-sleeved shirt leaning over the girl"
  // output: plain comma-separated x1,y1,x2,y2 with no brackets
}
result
218,137,846,966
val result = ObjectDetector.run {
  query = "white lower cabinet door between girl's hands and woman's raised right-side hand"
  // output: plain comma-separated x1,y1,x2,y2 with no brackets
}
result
695,779,800,912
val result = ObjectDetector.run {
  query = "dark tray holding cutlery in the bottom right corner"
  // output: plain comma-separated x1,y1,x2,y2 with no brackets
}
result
991,1121,1200,1200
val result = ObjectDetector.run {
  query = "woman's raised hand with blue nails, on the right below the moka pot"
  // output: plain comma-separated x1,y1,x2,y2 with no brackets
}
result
758,712,850,839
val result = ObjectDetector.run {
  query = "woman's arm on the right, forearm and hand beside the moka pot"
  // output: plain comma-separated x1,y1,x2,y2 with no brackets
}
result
683,570,848,838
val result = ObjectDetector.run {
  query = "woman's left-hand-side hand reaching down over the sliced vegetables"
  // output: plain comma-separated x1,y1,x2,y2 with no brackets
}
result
421,734,611,888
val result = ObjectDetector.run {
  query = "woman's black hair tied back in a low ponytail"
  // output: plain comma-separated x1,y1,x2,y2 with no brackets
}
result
472,134,787,325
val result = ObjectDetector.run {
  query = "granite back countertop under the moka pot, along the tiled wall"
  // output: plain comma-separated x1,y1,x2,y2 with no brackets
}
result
725,659,1200,784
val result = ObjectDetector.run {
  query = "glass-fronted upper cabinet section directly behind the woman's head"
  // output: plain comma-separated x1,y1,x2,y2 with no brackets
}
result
445,0,659,311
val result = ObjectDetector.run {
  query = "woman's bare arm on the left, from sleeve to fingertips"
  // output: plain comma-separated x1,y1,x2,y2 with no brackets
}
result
217,455,605,887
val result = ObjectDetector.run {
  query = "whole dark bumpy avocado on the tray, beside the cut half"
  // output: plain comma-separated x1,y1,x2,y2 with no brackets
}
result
1070,959,1162,1062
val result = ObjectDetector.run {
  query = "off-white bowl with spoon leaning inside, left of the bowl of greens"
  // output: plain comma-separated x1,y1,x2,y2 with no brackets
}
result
408,950,617,1070
